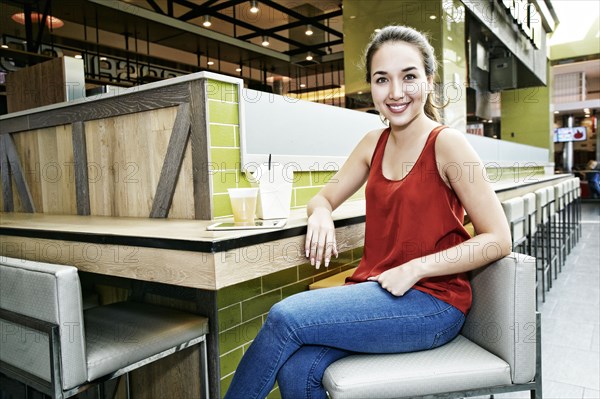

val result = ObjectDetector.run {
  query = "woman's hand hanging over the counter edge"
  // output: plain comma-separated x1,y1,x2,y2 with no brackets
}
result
304,208,338,269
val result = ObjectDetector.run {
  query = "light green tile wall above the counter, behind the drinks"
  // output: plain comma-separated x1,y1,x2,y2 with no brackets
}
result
206,80,365,218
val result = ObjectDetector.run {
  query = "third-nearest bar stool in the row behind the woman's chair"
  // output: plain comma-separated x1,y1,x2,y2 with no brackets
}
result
534,188,552,291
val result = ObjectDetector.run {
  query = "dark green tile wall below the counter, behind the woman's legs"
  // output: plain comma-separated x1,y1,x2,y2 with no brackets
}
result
217,249,362,398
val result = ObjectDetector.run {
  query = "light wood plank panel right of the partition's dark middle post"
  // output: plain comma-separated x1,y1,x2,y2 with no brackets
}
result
85,107,193,219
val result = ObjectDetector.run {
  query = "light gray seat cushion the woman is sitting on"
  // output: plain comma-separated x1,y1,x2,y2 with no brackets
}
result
323,335,511,399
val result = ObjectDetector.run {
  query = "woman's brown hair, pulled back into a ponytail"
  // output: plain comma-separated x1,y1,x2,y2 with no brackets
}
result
365,25,441,122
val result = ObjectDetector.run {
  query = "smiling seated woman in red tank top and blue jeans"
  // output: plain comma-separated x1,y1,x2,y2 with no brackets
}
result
226,26,511,399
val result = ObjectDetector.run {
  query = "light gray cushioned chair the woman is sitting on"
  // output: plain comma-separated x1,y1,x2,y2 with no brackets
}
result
323,253,542,399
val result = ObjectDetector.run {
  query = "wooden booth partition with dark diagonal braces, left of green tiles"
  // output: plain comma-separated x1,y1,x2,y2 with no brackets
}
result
0,77,212,219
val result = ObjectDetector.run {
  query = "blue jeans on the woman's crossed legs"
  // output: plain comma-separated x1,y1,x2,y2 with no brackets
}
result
225,282,465,399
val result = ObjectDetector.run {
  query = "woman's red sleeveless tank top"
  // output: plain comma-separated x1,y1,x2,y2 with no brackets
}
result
346,126,471,314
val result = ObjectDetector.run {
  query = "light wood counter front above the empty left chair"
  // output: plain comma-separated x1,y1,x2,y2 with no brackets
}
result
0,235,215,290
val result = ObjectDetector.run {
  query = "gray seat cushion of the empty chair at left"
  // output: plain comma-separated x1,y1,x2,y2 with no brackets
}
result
84,302,208,381
